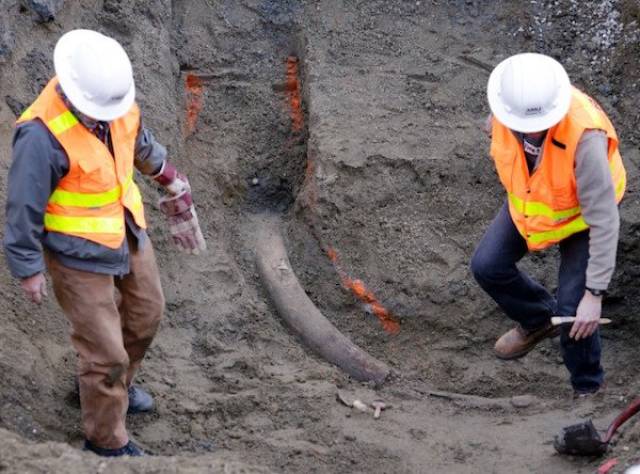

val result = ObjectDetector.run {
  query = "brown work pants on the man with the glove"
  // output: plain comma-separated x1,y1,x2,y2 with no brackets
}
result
47,239,164,449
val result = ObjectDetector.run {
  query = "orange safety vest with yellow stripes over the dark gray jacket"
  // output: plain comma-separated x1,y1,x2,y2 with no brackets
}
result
17,77,147,249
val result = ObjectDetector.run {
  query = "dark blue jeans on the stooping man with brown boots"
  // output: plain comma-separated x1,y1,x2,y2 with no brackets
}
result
471,203,604,392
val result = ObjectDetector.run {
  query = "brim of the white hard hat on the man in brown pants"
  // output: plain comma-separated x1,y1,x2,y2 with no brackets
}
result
53,30,136,122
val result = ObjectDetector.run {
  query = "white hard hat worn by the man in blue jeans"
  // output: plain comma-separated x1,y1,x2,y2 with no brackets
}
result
487,53,571,133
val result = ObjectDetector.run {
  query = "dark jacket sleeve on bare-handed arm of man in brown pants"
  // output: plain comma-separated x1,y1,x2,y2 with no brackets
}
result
3,120,69,278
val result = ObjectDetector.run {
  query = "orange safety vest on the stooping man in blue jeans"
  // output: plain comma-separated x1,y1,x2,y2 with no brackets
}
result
491,88,626,250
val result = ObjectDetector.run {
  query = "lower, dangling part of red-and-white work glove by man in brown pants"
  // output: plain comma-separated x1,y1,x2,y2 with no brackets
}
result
158,190,207,255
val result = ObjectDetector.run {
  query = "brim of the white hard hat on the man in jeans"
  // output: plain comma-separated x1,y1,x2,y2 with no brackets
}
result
487,54,571,133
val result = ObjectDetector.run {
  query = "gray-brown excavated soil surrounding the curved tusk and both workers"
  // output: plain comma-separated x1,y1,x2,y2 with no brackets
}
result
0,0,640,473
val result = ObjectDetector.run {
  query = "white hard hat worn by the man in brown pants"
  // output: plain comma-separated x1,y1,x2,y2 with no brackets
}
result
53,30,135,121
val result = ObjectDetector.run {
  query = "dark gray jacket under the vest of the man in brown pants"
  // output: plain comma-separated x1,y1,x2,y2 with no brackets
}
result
3,119,167,278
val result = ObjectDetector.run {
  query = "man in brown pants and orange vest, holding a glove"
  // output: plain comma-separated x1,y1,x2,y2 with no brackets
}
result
4,30,205,456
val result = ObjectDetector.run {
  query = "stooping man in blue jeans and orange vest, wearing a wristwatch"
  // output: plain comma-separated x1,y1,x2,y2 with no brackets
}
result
471,53,626,397
